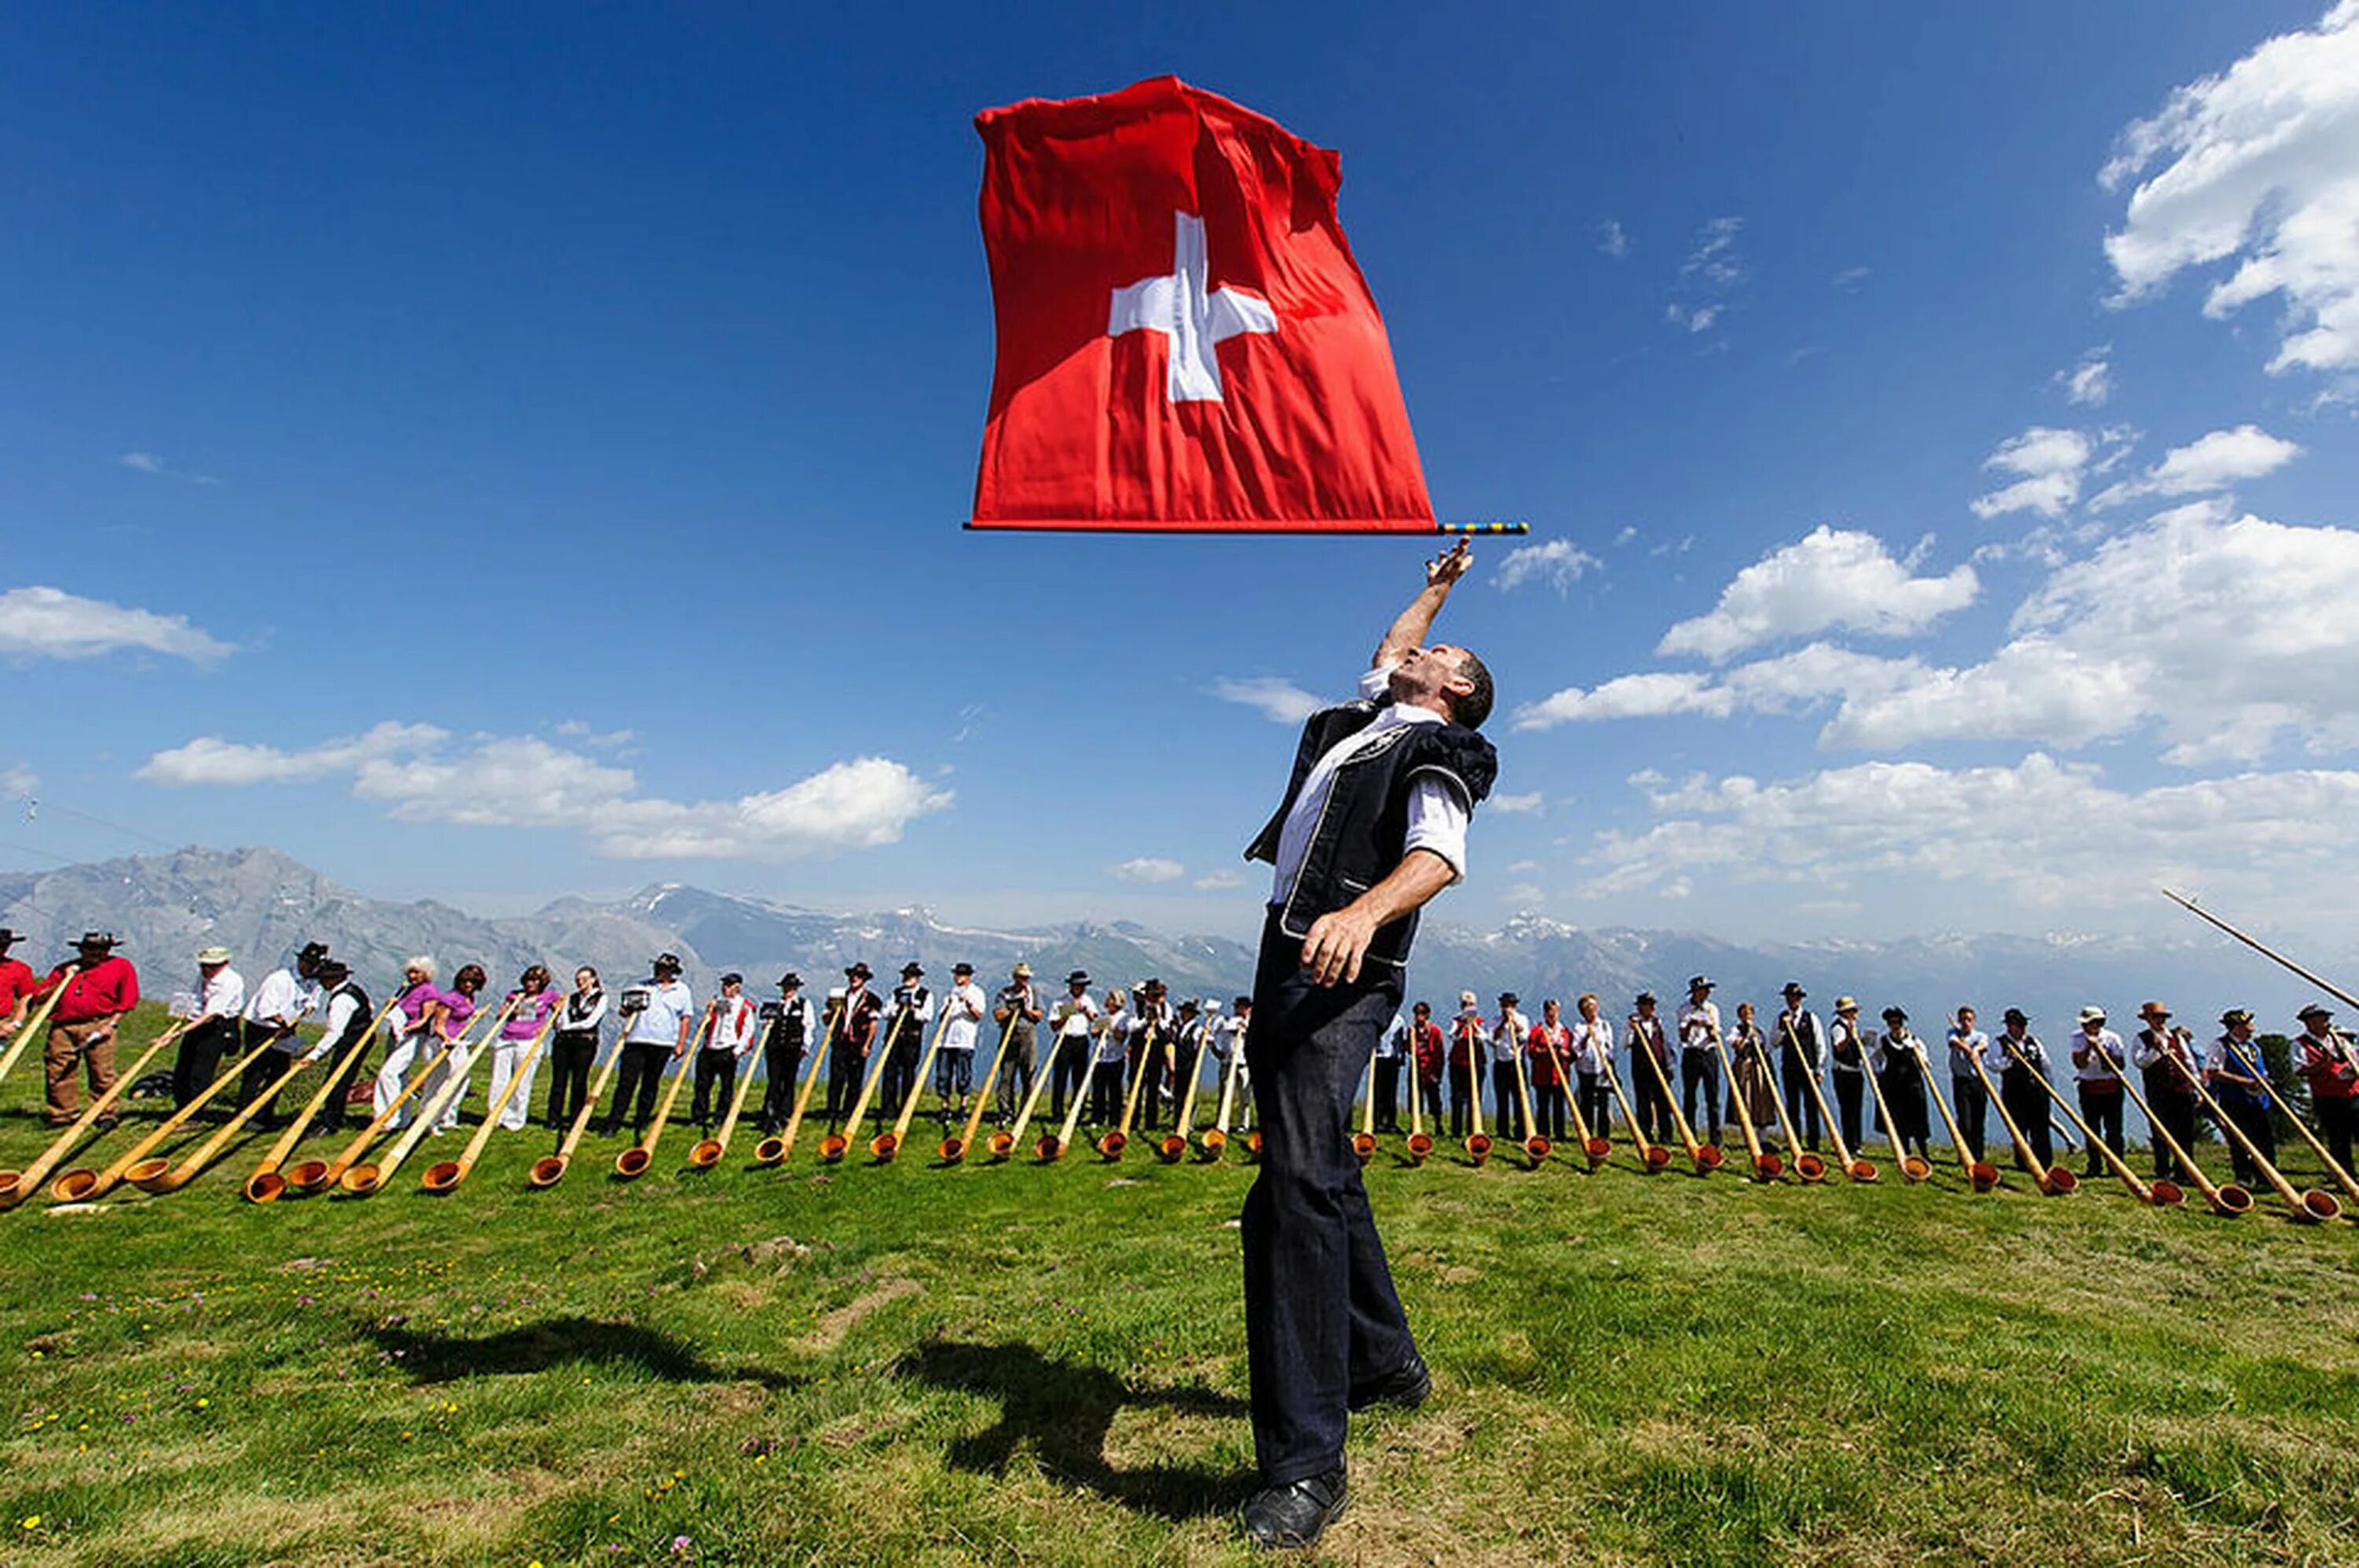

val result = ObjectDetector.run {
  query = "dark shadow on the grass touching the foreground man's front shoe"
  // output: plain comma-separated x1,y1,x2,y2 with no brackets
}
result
894,1339,1253,1523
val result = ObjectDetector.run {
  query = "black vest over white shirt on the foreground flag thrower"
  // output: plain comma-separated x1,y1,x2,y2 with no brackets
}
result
1246,703,1498,969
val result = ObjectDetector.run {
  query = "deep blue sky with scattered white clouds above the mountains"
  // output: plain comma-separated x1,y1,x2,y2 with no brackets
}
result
0,2,2359,936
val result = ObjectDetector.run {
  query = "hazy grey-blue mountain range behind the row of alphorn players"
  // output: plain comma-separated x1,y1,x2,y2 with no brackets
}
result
0,848,2312,1037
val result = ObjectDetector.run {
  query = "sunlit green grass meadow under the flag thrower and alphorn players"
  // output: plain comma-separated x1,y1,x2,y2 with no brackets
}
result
0,1004,2359,1566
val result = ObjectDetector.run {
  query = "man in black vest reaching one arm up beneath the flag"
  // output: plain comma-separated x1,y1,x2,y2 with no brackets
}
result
1241,540,1498,1547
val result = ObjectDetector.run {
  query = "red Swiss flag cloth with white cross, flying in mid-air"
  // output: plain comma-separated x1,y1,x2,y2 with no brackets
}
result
972,75,1434,533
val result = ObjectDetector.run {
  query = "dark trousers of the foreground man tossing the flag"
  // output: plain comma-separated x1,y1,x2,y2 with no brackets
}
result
1241,919,1415,1485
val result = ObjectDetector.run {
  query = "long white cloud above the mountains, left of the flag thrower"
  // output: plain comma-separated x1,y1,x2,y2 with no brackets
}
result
137,724,953,860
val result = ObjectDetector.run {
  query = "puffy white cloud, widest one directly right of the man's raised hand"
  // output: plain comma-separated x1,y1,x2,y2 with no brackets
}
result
1656,524,1982,663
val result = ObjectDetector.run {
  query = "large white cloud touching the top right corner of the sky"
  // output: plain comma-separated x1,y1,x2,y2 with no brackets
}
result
2100,0,2359,373
